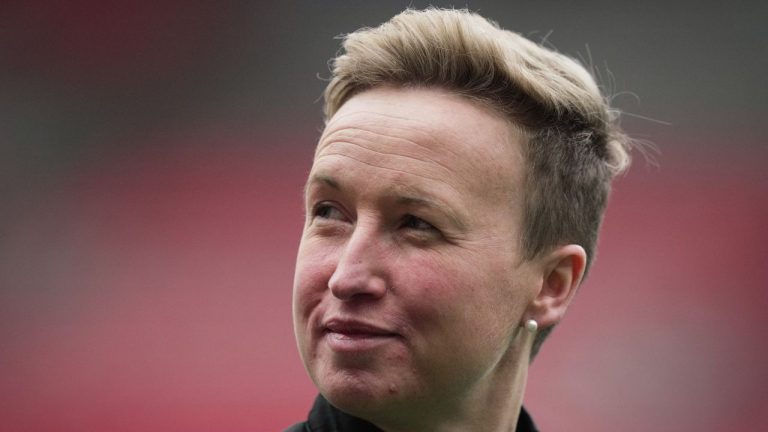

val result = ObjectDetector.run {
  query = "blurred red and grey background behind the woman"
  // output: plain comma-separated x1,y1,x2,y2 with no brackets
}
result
0,1,768,431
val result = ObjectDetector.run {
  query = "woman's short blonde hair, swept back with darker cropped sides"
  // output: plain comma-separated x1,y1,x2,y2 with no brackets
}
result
324,8,630,354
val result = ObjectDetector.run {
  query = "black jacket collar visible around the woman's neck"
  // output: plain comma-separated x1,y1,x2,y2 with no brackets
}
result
284,396,538,432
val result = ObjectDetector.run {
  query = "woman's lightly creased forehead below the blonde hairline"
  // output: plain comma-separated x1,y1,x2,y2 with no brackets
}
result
315,87,523,197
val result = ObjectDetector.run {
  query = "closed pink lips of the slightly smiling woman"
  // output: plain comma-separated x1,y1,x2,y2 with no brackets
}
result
321,318,400,352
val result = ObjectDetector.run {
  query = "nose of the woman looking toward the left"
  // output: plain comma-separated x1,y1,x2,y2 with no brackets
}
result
328,224,388,301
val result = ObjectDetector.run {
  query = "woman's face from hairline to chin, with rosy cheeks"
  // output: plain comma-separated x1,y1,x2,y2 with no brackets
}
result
293,88,540,421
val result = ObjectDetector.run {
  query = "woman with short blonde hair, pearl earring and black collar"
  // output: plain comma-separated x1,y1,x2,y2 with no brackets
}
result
288,9,629,431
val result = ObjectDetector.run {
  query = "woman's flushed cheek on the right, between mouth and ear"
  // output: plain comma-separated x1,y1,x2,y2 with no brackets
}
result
398,259,512,392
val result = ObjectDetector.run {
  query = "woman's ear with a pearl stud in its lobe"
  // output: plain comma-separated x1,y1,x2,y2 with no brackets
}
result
527,244,587,328
